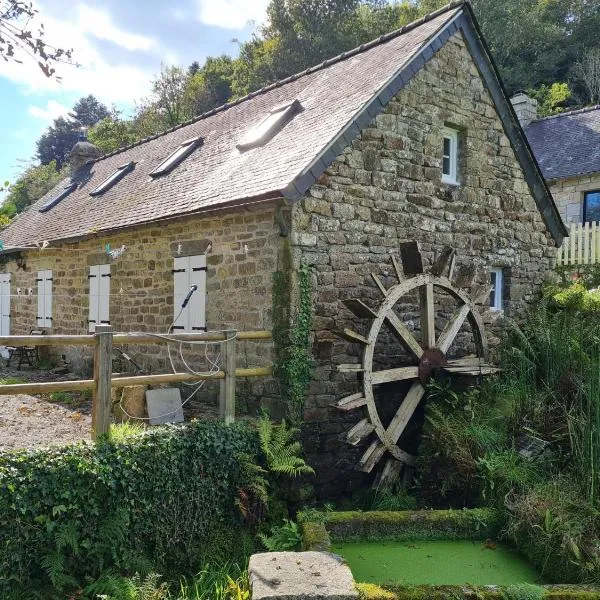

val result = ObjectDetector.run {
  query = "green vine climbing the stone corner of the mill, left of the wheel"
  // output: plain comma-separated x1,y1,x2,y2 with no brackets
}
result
273,255,312,424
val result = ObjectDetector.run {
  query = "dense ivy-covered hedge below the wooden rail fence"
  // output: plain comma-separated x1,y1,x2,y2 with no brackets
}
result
0,422,258,598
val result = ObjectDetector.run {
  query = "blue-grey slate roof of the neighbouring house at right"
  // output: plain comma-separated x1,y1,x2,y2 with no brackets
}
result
525,106,600,180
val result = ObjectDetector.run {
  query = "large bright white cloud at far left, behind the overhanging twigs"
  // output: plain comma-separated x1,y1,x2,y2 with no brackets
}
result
0,5,155,104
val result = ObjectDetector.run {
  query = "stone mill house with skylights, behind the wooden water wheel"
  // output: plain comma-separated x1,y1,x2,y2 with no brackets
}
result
0,3,566,495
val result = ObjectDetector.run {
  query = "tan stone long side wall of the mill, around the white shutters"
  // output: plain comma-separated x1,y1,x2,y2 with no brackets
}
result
0,203,281,418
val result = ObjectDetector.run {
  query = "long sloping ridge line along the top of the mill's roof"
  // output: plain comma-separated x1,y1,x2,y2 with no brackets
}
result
90,0,468,164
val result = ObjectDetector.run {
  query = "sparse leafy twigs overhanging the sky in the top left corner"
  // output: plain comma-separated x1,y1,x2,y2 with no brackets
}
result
0,0,73,79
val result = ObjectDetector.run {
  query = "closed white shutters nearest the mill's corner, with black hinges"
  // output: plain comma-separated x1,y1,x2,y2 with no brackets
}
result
172,254,206,333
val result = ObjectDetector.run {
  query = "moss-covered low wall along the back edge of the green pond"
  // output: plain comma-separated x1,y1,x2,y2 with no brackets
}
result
324,508,498,542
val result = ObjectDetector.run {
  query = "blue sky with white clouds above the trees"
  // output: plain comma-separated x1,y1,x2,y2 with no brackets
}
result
0,0,268,190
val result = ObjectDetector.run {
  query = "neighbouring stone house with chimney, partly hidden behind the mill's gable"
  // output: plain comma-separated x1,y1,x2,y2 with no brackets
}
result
511,92,600,224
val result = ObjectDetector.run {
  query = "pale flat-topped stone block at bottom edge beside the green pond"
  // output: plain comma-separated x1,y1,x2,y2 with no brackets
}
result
248,552,358,600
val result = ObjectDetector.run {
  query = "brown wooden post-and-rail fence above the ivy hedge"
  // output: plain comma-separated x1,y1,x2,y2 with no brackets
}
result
0,325,272,439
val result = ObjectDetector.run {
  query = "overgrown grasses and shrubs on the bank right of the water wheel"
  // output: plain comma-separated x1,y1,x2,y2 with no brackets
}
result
417,282,600,583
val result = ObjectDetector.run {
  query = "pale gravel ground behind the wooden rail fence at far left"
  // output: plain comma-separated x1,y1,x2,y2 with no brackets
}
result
0,368,92,450
